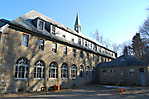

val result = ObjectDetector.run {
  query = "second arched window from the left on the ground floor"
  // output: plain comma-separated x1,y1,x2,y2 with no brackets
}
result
34,60,45,78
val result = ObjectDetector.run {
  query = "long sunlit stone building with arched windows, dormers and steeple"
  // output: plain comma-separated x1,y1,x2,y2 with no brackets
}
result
0,11,116,92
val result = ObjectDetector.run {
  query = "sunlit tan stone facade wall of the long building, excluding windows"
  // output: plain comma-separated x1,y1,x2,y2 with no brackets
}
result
0,28,110,92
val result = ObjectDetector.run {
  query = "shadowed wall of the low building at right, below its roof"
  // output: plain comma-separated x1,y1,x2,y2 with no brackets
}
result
96,66,149,85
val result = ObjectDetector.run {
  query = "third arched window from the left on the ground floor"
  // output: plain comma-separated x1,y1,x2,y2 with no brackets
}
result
49,62,58,78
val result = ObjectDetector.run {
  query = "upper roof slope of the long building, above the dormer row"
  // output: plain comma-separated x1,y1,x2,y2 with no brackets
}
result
12,10,115,53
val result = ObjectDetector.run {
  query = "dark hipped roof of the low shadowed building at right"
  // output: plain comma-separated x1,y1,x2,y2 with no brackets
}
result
97,55,147,67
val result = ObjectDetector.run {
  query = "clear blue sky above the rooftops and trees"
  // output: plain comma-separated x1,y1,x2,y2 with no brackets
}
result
0,0,149,44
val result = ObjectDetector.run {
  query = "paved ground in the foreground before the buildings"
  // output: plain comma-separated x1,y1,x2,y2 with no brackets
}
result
0,86,149,99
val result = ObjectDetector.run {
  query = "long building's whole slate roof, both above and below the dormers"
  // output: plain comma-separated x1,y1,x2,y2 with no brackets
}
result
0,10,116,58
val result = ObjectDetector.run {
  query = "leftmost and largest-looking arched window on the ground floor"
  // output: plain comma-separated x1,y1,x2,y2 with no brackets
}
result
15,58,29,78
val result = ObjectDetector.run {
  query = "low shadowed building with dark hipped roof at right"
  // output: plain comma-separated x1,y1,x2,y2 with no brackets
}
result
96,55,149,86
